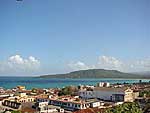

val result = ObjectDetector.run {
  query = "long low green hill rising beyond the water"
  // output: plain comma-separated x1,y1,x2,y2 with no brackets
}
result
40,69,150,79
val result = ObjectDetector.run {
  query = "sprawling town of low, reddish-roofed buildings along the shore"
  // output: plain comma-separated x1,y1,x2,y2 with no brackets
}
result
0,81,150,113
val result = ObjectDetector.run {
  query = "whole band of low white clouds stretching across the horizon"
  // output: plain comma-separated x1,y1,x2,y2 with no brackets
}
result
0,55,150,76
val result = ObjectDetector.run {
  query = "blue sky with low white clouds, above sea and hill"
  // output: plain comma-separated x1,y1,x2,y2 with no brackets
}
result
0,0,150,76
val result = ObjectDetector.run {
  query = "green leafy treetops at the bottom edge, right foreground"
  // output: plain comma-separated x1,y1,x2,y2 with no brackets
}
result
105,102,143,113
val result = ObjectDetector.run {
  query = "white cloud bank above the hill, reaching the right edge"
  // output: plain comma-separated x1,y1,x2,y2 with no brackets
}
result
68,56,150,72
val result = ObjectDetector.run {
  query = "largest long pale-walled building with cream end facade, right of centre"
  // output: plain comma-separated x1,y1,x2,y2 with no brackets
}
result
79,87,134,102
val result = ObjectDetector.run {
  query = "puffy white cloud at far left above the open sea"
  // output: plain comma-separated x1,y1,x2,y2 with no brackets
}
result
0,55,40,74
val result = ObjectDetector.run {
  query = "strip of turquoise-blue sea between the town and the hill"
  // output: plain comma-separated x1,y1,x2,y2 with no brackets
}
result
0,77,150,89
